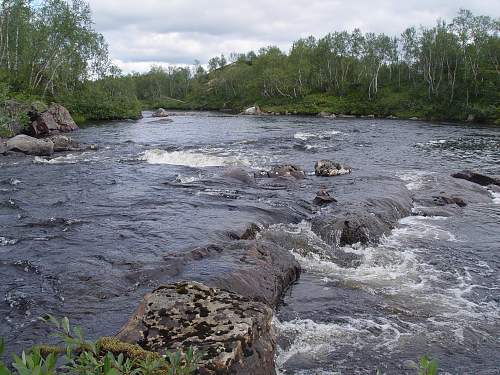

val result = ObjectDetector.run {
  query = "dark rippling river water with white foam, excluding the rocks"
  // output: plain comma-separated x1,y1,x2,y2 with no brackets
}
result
0,113,500,374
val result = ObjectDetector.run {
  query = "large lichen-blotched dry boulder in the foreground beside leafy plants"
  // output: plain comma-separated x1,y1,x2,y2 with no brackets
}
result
117,282,276,375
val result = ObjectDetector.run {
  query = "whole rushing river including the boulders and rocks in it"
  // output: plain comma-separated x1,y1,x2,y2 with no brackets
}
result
0,113,500,374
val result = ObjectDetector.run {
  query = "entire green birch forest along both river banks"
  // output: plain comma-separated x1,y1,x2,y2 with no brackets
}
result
0,0,500,135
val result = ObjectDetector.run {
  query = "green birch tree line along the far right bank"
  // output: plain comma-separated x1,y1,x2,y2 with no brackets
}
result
134,10,500,120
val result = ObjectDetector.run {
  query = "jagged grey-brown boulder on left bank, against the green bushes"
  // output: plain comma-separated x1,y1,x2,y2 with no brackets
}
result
28,103,78,138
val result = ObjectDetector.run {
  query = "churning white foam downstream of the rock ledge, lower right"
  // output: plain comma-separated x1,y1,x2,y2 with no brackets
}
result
275,216,500,373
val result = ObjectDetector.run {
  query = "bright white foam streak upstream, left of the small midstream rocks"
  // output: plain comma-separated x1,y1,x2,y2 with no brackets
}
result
141,149,246,168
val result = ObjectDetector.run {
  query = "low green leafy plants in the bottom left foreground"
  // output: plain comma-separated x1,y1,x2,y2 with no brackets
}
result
0,315,200,375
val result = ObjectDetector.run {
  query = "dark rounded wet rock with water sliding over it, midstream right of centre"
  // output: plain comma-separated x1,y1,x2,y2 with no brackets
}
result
311,194,413,248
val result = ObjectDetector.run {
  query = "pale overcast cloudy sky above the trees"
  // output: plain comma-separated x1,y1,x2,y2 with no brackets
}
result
89,0,500,73
